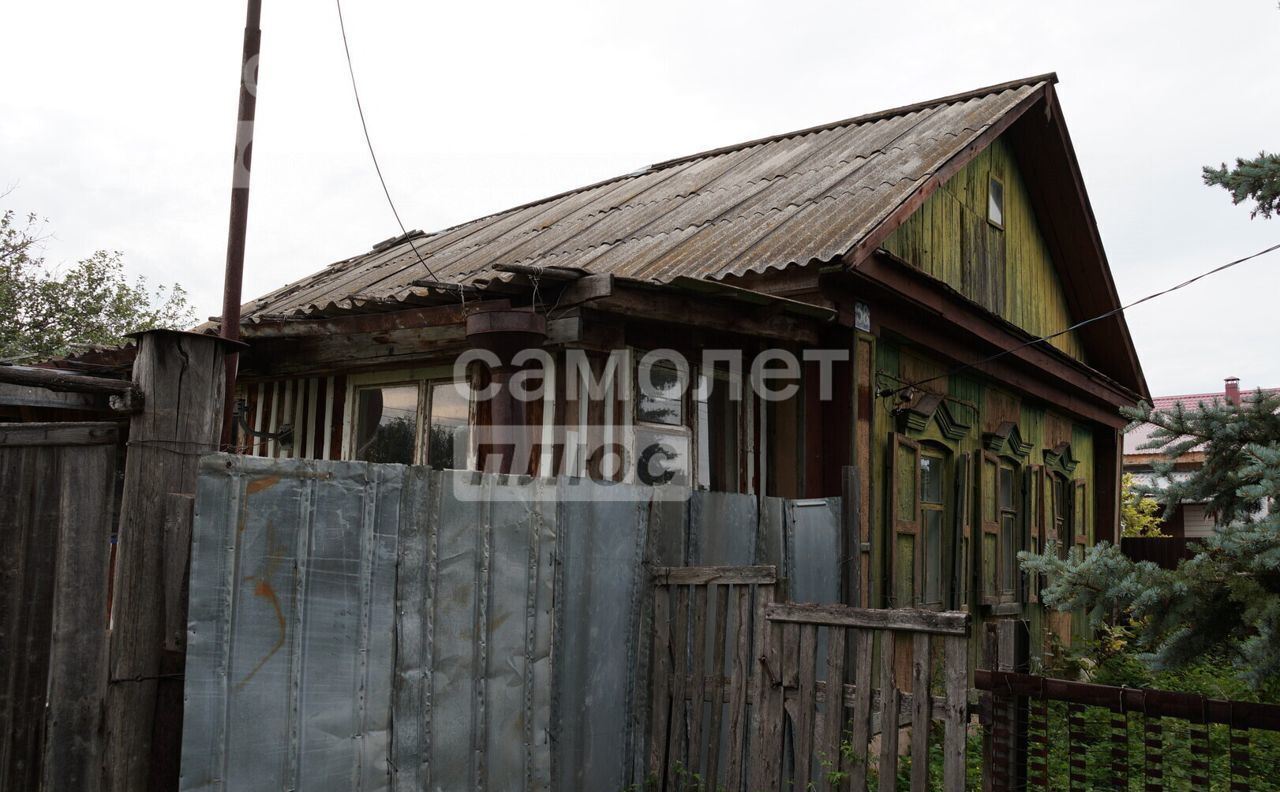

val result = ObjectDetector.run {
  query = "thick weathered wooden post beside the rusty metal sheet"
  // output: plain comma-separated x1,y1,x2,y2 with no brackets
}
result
104,330,227,792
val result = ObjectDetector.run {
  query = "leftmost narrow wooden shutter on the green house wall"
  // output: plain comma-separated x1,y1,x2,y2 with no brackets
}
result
884,432,924,608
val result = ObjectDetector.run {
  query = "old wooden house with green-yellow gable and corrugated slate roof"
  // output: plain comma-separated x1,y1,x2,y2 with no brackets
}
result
215,74,1148,654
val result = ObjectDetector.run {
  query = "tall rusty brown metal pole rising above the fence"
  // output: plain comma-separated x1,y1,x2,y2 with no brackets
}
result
221,0,262,450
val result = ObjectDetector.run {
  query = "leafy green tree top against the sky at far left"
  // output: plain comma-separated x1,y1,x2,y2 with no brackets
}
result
0,210,195,362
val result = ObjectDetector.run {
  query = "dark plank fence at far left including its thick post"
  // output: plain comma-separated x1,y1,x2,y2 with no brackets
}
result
0,330,225,792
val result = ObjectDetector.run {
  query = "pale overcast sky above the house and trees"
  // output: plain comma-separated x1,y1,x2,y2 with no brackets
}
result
0,0,1280,395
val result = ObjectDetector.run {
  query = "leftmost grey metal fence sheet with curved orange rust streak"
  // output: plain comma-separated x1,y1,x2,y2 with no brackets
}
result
180,455,403,791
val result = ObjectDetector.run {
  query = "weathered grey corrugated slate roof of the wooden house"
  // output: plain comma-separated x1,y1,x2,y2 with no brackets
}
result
243,75,1055,321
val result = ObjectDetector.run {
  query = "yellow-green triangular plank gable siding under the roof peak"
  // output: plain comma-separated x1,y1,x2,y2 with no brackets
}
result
883,138,1085,361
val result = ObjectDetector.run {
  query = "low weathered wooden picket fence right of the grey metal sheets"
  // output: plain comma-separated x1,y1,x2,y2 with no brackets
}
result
646,567,969,792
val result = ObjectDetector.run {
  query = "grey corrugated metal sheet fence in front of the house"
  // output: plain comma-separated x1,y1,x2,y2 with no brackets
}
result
182,455,840,791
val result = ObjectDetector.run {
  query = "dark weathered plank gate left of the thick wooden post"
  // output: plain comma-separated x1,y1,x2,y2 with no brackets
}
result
0,424,116,791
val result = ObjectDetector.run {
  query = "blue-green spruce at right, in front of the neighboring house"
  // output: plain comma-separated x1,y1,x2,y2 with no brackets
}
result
1019,390,1280,685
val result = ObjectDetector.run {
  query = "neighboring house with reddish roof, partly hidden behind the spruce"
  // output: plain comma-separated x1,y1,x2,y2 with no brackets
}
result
1124,376,1280,539
